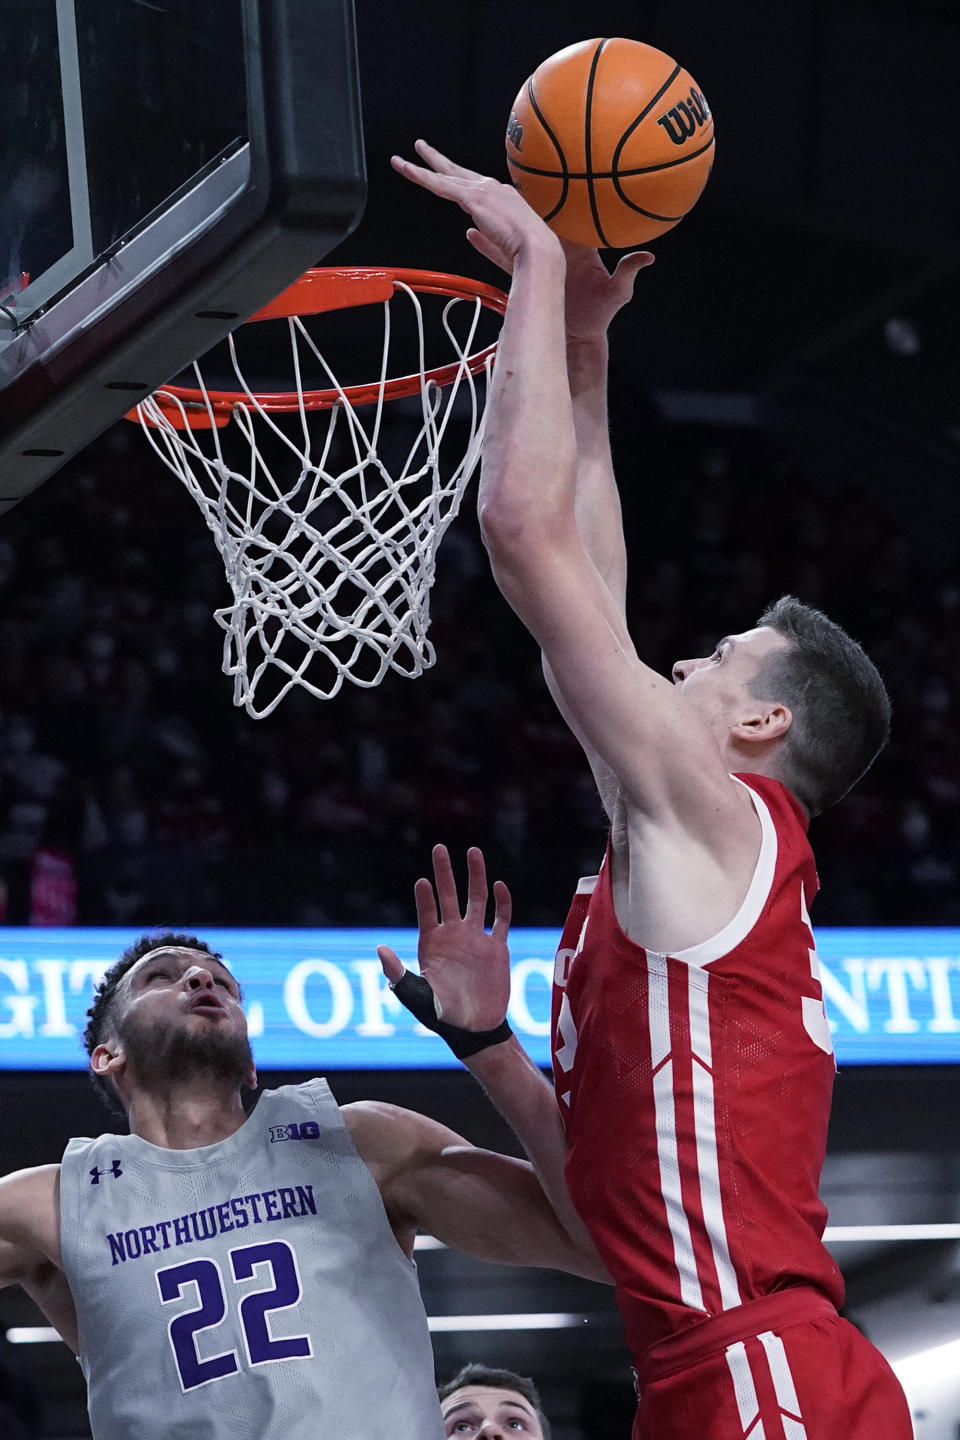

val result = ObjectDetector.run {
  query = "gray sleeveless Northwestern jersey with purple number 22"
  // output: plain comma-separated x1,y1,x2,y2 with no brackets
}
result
60,1080,443,1440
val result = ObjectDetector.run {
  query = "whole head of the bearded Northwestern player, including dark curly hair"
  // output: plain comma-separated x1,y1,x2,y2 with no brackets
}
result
83,932,256,1109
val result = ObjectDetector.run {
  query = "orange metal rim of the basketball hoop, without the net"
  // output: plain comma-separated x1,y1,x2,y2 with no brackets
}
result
136,265,507,429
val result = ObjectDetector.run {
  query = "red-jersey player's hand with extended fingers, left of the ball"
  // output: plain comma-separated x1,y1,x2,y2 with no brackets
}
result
390,140,560,272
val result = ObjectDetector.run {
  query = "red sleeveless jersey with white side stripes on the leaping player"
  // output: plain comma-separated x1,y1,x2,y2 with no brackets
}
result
553,775,843,1355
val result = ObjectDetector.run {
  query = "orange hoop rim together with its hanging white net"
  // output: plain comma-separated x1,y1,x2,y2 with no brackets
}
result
128,269,507,719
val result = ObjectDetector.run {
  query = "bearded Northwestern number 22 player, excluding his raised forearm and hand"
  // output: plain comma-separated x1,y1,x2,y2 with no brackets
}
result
0,933,603,1440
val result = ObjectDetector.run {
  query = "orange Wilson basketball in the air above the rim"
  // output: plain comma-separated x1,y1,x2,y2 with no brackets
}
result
507,39,714,249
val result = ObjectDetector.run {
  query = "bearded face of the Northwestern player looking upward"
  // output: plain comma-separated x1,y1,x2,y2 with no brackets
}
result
117,946,253,1083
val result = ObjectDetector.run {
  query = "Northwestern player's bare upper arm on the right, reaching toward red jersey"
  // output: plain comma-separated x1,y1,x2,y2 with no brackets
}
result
343,1102,609,1280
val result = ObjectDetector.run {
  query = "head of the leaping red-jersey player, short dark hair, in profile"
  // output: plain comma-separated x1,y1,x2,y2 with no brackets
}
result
674,595,889,815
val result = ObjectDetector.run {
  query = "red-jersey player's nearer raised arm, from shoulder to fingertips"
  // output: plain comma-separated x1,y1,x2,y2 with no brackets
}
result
394,143,754,848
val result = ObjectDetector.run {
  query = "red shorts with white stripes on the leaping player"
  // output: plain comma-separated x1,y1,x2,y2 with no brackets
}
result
633,1287,914,1440
